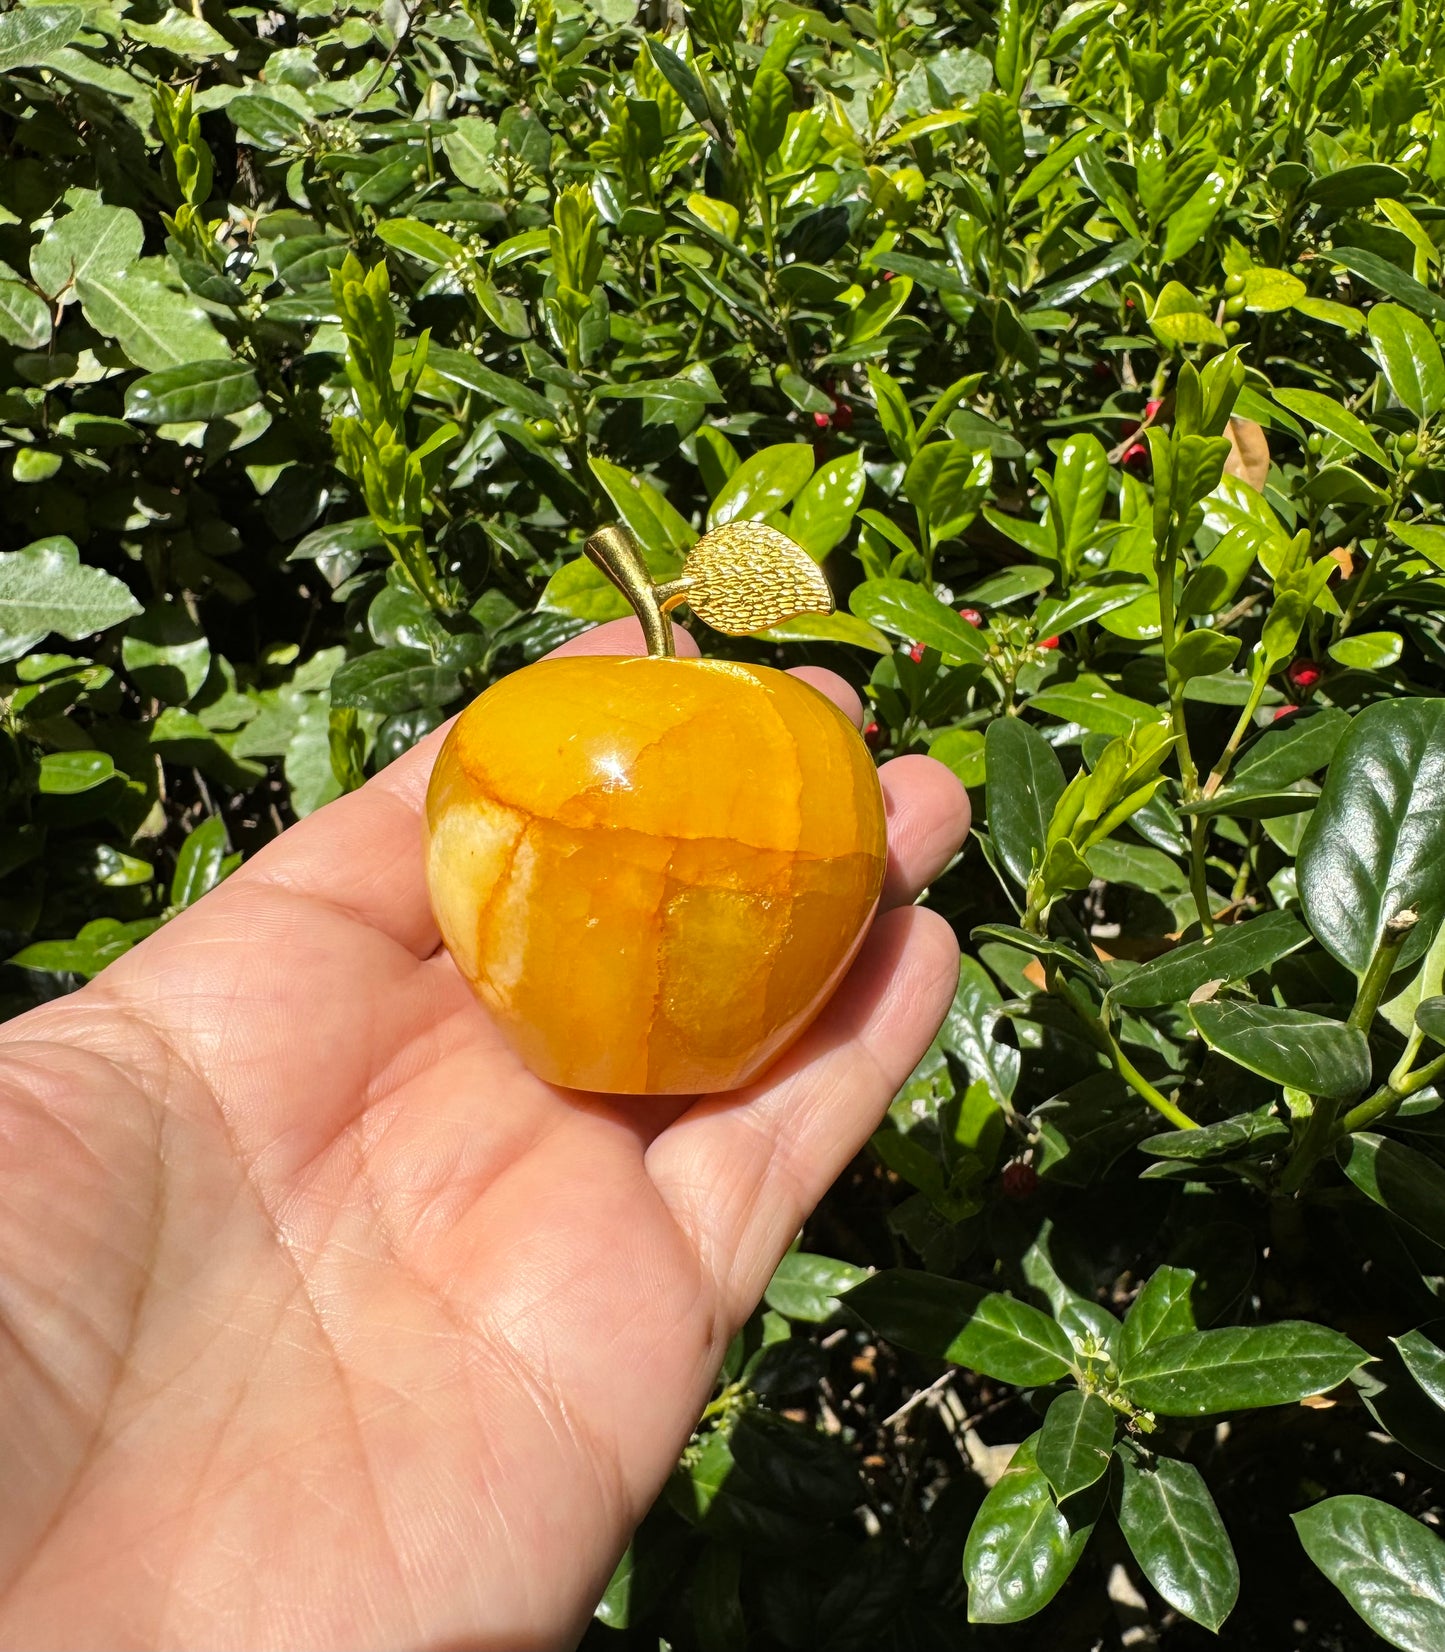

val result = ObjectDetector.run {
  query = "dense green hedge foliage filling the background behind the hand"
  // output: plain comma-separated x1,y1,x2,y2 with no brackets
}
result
0,0,1445,1652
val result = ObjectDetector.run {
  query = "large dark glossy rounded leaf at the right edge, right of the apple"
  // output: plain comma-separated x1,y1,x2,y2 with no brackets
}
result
1296,699,1445,975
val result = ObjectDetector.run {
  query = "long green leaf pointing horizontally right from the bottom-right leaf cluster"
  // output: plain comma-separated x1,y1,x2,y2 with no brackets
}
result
1121,1320,1367,1417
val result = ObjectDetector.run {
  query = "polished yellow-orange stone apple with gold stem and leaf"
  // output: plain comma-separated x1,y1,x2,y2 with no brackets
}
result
426,522,887,1095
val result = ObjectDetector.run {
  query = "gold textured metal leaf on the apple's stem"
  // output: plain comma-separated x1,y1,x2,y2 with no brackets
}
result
679,522,832,636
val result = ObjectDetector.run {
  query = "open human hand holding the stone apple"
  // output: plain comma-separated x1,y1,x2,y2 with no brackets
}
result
0,621,968,1652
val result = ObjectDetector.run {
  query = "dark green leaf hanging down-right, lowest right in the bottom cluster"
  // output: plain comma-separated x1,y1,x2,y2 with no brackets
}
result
1115,1441,1239,1632
